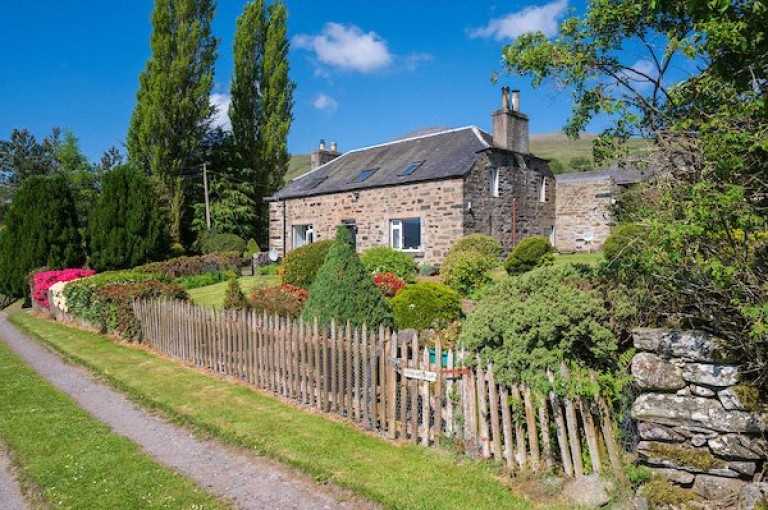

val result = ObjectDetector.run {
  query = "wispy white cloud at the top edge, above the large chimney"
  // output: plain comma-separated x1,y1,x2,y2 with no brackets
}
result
469,0,568,41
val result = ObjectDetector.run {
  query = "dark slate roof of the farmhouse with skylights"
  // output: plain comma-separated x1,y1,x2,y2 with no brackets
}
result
270,126,493,200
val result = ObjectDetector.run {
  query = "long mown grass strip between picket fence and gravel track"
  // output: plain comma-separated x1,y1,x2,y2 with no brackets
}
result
11,313,532,510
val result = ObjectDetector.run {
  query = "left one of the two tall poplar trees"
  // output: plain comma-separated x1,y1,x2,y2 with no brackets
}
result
127,0,218,242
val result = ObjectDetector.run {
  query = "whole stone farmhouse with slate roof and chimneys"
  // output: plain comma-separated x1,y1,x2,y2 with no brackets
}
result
268,87,556,262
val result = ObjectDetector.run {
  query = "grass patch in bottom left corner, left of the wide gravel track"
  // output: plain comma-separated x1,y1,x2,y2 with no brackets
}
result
0,336,225,509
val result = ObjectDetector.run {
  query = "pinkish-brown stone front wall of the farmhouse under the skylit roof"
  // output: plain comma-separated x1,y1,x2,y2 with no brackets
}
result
269,179,464,262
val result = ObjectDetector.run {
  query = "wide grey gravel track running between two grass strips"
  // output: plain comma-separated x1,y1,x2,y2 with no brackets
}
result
0,313,375,509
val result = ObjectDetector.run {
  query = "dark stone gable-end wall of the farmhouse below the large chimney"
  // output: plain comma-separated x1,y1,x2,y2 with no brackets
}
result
464,152,556,255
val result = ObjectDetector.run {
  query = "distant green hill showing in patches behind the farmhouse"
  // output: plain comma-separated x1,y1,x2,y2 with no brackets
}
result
285,128,647,182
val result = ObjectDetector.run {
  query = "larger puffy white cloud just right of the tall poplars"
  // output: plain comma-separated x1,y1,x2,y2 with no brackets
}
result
293,23,393,73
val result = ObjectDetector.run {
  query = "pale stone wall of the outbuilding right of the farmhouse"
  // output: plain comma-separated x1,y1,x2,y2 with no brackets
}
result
555,177,617,253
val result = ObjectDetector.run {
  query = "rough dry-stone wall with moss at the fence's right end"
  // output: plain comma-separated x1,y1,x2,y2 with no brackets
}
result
632,329,768,499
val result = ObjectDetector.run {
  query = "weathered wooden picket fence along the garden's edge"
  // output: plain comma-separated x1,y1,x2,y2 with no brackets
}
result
134,300,623,479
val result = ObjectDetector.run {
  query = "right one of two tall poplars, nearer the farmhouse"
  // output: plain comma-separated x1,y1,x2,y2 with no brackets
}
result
229,0,295,245
